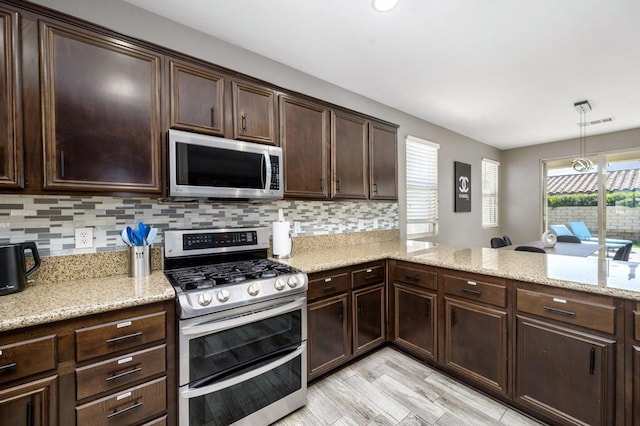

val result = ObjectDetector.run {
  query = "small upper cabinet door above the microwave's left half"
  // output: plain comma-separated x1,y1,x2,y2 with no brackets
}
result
170,60,224,136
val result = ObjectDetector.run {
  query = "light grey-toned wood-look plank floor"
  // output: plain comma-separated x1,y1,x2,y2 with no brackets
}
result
275,347,541,426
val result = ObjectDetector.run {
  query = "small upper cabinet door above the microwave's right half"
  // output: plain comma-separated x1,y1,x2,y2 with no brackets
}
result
232,81,277,145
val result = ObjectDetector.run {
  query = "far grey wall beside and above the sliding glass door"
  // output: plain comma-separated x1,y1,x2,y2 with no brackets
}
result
500,129,640,243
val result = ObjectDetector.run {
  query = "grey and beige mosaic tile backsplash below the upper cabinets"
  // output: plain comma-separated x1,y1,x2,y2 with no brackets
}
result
0,194,398,256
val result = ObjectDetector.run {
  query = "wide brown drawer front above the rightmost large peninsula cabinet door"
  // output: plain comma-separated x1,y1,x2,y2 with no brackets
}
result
516,289,616,334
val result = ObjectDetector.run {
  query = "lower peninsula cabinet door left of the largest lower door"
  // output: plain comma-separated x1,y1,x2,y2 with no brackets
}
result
444,297,508,394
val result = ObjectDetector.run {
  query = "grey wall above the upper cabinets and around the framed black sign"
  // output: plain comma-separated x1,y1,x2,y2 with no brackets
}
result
28,0,501,246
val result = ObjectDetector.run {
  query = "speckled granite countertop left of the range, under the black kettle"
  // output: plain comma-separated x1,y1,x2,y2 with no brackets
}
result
0,271,175,332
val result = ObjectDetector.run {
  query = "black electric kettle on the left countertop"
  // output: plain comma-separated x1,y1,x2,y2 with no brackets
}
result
0,242,40,296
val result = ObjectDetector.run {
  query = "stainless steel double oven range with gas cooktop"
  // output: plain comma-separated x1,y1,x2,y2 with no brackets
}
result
164,228,307,426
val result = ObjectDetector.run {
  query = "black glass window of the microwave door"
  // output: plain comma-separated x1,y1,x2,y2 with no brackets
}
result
176,142,267,189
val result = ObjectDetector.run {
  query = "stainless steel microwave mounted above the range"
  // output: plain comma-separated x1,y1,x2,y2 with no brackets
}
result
168,129,284,199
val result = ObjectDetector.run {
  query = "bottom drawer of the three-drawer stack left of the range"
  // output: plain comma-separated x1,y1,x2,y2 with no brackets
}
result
76,377,167,426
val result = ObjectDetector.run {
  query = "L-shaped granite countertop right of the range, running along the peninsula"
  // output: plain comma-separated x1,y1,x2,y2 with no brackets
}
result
277,240,640,300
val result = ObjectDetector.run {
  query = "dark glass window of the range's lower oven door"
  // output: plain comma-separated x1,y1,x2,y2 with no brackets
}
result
189,356,306,426
